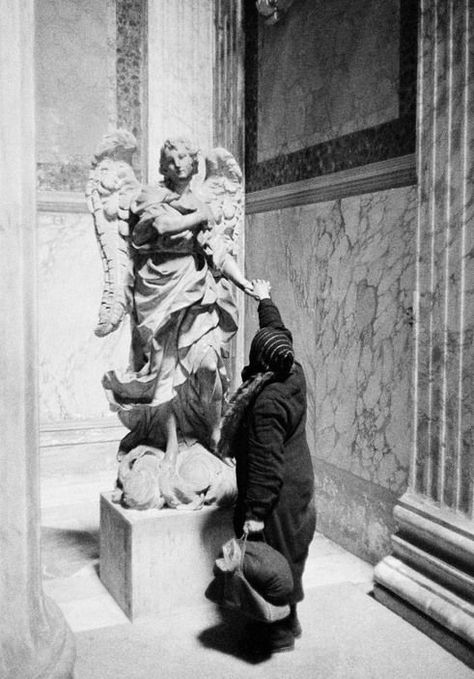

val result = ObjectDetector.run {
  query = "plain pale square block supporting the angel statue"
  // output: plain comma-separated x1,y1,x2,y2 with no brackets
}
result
100,493,234,621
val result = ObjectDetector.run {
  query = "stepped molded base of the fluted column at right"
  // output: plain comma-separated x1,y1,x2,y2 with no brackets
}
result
374,494,474,667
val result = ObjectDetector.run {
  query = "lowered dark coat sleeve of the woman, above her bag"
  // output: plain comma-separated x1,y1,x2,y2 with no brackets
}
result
245,390,288,521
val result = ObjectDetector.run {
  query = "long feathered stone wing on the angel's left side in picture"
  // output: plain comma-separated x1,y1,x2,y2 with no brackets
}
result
86,130,141,337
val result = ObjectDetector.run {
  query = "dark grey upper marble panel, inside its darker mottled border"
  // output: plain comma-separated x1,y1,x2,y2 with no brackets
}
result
257,0,400,161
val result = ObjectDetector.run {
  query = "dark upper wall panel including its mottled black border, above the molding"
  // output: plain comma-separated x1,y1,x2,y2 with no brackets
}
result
245,0,418,192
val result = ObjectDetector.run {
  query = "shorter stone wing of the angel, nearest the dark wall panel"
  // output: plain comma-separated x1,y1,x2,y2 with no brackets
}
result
201,147,244,255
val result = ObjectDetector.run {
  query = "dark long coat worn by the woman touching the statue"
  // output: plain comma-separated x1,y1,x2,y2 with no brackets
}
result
234,299,315,603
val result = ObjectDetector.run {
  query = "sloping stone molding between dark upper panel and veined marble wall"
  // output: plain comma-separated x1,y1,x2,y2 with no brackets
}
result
245,154,417,214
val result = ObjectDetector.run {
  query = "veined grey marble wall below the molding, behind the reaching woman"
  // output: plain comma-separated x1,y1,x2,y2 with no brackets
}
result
245,187,416,561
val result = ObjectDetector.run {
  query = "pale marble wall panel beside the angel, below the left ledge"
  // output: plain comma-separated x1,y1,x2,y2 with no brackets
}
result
38,213,129,424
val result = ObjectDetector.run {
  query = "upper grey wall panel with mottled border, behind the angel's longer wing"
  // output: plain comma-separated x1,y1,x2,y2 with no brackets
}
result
35,0,147,191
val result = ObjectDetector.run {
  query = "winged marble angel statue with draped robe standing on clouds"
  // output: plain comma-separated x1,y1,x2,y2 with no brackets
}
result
86,130,252,508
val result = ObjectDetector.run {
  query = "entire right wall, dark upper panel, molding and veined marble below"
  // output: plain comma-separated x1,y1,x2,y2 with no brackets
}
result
245,0,418,562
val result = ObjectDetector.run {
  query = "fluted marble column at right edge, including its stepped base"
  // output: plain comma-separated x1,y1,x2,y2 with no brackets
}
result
375,0,474,660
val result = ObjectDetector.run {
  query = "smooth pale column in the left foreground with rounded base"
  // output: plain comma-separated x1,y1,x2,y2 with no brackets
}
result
0,0,75,679
